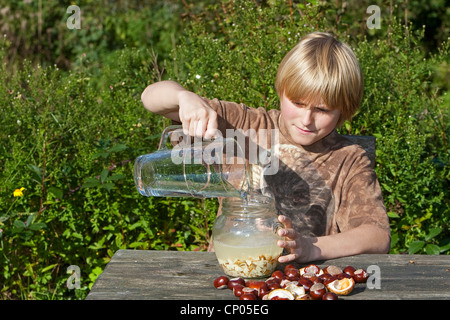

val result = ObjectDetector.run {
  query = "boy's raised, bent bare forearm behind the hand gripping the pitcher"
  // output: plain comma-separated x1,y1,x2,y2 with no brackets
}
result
141,81,187,121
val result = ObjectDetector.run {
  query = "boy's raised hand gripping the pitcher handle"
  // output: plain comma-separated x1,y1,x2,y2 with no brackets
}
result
178,91,217,139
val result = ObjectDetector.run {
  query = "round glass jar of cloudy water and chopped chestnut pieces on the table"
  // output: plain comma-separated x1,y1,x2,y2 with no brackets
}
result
212,196,283,278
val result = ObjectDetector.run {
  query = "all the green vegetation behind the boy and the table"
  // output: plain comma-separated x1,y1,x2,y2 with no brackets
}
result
0,0,450,299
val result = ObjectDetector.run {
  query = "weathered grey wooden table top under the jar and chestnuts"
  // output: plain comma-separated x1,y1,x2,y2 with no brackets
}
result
87,250,450,302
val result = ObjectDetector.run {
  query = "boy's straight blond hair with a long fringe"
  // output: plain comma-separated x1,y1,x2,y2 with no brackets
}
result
275,32,364,125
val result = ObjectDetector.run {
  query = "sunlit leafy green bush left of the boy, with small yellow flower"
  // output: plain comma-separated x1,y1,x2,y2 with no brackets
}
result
0,40,217,299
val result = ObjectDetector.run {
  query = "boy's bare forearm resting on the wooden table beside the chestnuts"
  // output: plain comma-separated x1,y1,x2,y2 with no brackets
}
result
305,225,390,261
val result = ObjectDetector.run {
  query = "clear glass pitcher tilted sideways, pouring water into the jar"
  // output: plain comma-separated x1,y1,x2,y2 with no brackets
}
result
134,126,249,198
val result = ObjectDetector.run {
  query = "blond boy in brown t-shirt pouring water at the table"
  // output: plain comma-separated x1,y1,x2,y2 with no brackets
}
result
141,32,390,263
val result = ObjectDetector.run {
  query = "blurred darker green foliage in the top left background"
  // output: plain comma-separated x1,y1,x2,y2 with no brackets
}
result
0,0,183,70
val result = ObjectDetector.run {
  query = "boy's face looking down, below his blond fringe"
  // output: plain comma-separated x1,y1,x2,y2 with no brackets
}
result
281,94,341,146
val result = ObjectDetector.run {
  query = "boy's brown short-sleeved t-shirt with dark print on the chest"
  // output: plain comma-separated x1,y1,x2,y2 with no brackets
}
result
205,98,389,236
